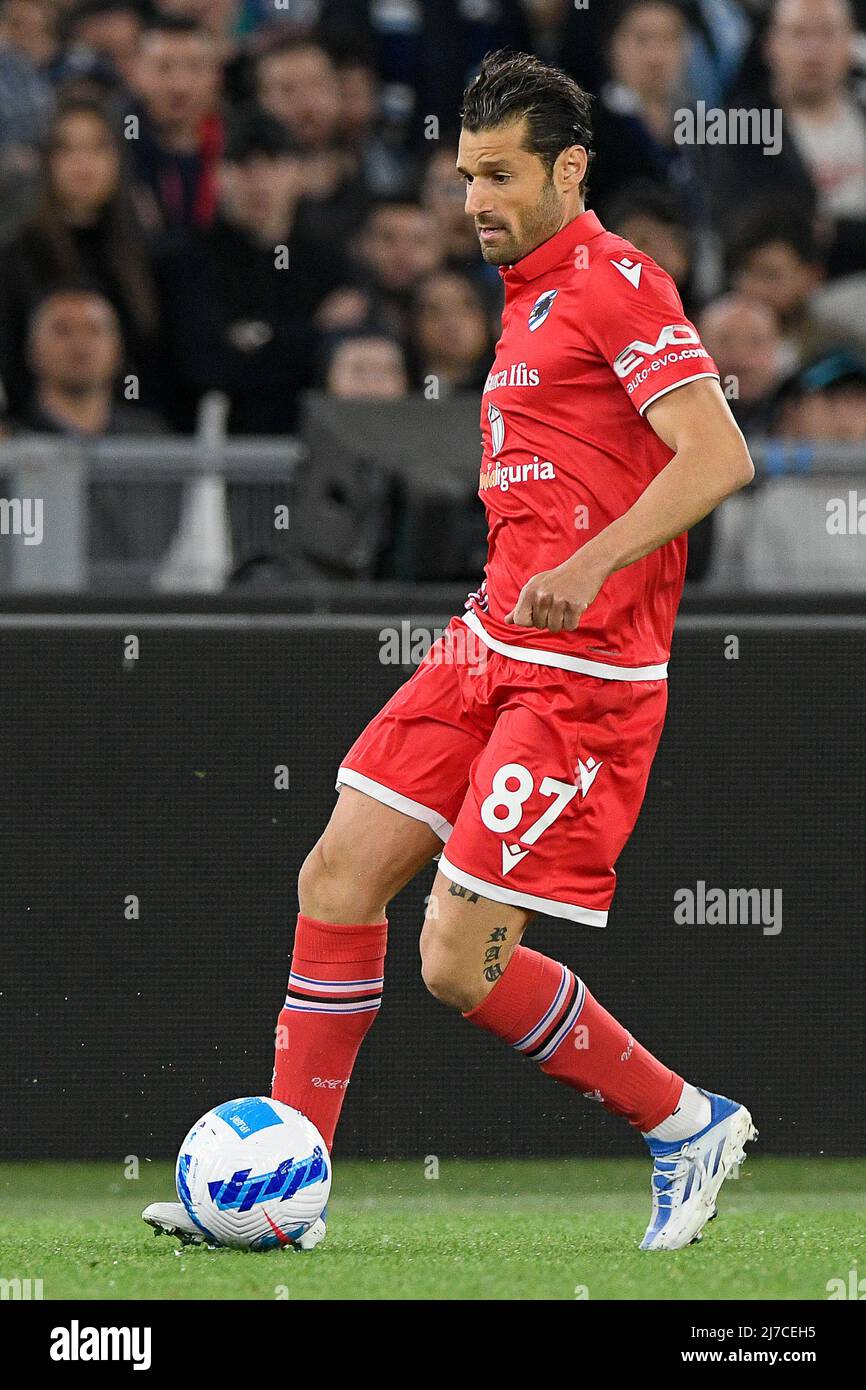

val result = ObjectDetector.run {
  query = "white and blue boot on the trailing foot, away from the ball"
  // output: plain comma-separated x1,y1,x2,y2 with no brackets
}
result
639,1087,758,1250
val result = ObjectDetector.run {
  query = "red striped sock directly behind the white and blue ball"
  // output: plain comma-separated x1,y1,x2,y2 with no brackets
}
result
271,913,388,1148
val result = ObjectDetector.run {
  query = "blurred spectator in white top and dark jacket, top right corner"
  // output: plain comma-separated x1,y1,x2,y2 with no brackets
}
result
716,0,866,277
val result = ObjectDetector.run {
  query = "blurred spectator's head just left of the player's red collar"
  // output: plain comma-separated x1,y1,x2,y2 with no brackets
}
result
347,197,445,338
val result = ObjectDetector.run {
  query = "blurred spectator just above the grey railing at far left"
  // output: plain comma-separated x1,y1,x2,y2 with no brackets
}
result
17,286,181,575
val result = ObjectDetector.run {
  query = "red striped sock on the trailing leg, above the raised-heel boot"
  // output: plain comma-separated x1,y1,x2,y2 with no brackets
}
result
464,947,683,1133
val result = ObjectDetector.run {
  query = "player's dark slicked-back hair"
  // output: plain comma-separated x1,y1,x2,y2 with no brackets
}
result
460,49,594,193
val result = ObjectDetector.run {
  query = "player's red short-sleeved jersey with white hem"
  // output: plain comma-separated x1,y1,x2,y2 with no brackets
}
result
464,211,719,680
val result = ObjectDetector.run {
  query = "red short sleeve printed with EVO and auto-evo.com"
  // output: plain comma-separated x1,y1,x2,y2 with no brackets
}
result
584,250,719,414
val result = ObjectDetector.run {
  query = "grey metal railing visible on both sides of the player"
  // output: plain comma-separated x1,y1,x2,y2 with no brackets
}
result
0,411,866,592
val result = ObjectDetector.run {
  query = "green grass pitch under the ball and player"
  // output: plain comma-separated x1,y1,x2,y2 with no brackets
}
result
0,1158,866,1301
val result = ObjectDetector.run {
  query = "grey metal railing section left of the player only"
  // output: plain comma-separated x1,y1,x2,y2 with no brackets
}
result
0,435,306,591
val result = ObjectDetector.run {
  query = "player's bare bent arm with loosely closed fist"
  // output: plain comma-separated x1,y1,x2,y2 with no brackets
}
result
505,377,755,632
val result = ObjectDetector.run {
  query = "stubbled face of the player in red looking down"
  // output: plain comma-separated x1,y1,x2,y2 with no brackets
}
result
457,120,569,265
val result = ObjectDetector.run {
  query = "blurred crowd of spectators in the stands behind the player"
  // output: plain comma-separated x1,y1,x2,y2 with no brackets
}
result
0,0,866,583
